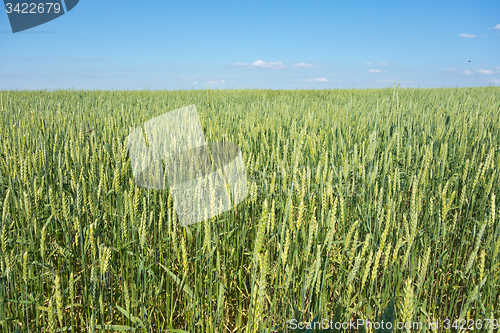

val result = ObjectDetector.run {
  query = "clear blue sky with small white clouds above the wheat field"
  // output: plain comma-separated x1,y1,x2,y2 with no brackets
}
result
0,0,500,90
